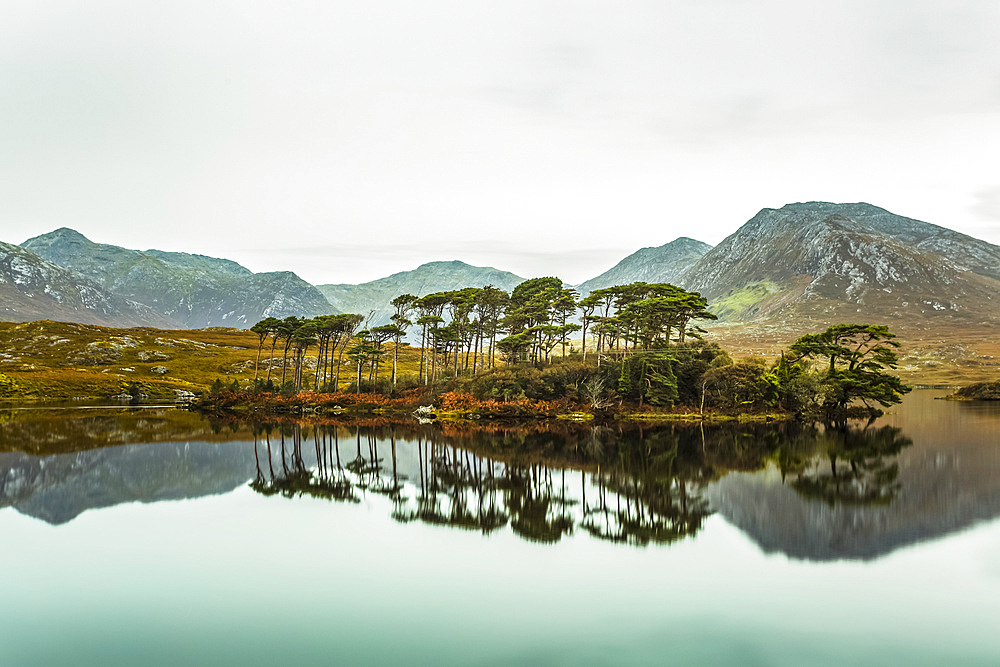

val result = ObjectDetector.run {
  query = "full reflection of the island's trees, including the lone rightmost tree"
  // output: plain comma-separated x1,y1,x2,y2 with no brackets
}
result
242,422,912,545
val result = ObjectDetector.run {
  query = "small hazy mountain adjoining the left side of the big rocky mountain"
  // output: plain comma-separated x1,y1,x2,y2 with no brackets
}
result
577,236,712,295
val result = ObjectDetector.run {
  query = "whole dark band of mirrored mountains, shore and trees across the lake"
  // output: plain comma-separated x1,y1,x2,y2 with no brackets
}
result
0,398,1000,560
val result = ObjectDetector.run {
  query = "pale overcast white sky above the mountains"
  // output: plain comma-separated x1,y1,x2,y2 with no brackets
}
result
0,0,1000,283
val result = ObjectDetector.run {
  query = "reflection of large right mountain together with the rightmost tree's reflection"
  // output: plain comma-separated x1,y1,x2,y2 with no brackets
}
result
708,392,1000,560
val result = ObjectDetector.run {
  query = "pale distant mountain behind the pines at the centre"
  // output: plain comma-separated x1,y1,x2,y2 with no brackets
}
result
318,260,524,326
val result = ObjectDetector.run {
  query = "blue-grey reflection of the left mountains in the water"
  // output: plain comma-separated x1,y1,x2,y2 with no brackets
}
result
0,442,254,524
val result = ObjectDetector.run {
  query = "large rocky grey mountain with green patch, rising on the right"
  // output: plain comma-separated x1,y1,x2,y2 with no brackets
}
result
679,202,1000,325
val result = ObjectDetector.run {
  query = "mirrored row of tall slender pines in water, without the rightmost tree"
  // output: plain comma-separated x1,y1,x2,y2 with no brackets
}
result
251,424,720,544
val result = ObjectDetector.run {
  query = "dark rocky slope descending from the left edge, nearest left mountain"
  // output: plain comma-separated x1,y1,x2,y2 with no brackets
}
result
0,242,167,327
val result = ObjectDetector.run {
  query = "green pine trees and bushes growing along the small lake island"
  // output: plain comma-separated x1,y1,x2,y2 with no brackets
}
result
232,277,909,414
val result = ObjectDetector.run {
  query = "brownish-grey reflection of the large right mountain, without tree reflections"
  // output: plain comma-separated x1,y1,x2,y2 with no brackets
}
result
708,397,1000,560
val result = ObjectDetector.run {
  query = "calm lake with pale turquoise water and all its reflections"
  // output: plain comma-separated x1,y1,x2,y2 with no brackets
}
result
0,390,1000,665
